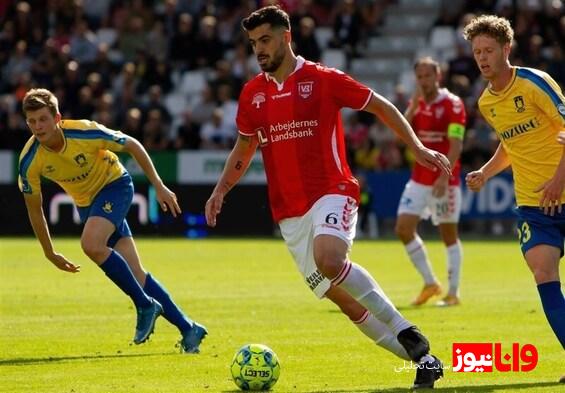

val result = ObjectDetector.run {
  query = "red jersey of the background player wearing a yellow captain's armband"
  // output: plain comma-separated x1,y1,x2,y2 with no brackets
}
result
412,89,466,186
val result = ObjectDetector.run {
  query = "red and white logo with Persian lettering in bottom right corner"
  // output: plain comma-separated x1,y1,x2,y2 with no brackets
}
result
453,343,538,373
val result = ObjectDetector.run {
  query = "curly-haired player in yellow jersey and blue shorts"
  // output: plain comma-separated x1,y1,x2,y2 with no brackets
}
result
463,15,565,380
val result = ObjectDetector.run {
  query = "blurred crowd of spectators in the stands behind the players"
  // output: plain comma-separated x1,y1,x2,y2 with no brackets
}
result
0,0,565,175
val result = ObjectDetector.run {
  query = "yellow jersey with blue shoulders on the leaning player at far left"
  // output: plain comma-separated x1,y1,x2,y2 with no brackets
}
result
18,120,126,206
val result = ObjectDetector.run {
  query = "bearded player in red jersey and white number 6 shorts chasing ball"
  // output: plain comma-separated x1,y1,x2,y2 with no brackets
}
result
206,6,450,388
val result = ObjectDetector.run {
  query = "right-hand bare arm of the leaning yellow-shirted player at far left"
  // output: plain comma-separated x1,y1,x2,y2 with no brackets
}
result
123,136,181,217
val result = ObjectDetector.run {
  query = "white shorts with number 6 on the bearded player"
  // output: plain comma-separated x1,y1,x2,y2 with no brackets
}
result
279,194,357,299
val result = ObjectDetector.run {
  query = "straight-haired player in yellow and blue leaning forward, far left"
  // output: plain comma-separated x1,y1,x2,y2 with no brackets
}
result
18,89,207,353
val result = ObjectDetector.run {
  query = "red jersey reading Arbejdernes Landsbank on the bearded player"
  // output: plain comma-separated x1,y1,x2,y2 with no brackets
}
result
237,56,372,222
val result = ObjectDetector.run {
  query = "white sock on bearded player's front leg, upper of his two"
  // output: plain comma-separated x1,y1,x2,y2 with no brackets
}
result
332,261,413,336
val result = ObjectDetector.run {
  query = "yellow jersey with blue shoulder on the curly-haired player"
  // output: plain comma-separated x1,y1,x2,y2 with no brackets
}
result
479,67,565,206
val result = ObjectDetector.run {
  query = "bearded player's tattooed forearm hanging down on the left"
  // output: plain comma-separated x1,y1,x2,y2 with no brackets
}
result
206,134,259,227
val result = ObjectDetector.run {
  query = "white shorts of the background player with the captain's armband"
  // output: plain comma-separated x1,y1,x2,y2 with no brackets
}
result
397,180,461,225
